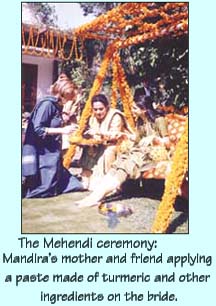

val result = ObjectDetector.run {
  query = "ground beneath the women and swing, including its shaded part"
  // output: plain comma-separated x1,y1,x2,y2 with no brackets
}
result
22,180,188,234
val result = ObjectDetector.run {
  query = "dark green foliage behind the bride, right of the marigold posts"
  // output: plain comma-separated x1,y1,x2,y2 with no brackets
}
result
121,36,188,107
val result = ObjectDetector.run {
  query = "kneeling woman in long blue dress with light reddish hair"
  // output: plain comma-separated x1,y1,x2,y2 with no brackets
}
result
22,80,84,198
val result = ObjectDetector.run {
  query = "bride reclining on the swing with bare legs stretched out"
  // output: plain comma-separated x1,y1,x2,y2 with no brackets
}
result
77,96,169,207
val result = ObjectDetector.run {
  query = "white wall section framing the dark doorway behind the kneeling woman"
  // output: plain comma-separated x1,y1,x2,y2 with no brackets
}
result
22,55,54,100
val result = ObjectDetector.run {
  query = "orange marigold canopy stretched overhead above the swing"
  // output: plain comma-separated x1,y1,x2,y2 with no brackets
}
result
73,2,188,40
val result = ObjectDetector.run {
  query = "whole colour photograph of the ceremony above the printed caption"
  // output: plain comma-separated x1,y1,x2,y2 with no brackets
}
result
20,2,190,234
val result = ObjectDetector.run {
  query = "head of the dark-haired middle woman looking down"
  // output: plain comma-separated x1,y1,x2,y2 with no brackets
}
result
91,94,109,121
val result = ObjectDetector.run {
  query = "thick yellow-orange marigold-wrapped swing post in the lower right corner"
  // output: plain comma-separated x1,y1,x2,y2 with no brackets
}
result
151,120,188,233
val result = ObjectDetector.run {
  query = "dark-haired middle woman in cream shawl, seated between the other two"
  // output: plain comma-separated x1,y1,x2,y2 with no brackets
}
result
80,94,132,189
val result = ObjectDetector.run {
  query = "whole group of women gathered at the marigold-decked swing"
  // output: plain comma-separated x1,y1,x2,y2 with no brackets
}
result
22,74,172,207
